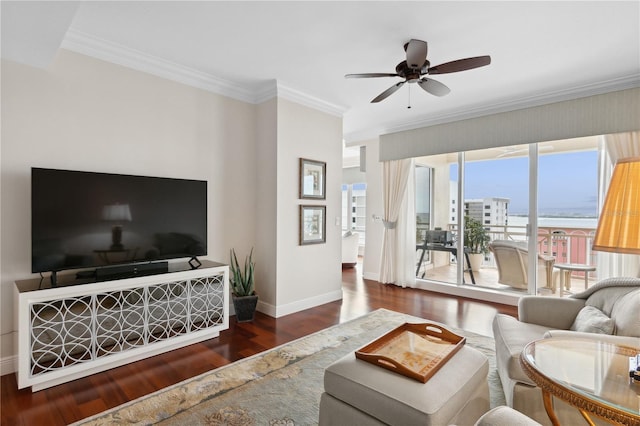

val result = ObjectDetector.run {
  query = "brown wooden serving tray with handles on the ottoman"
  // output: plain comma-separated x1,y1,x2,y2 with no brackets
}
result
356,323,466,383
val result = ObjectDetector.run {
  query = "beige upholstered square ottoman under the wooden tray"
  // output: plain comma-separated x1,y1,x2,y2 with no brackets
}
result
319,345,489,426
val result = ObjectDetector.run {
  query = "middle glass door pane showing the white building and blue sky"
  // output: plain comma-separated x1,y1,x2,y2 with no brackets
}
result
462,145,530,292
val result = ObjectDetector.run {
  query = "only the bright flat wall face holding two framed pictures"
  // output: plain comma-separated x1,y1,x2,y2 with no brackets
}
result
271,98,342,317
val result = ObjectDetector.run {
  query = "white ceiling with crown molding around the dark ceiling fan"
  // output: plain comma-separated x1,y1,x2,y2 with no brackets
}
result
1,0,640,145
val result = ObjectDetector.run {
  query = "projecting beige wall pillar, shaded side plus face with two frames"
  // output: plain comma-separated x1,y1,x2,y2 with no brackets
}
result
254,97,342,317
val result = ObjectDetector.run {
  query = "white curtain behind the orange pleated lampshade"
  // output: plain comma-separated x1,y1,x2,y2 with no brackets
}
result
596,132,640,279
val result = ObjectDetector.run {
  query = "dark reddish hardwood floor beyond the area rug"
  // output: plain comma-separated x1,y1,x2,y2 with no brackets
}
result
0,269,517,426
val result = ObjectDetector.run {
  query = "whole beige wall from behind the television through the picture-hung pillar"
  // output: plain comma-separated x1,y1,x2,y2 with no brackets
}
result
0,50,350,372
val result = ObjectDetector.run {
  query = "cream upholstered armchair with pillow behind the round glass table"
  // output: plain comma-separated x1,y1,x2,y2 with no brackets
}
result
493,278,640,425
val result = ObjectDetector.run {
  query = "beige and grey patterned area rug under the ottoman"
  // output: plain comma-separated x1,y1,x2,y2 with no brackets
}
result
74,309,504,426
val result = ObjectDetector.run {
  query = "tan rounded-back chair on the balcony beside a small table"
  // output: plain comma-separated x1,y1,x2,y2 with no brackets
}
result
489,240,555,291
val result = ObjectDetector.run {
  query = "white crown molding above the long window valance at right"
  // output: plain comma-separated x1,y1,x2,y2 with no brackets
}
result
344,74,640,146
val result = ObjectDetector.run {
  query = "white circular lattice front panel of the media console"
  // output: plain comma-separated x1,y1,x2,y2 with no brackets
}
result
30,274,225,377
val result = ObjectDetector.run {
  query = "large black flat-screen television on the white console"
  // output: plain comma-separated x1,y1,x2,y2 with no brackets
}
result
31,168,207,272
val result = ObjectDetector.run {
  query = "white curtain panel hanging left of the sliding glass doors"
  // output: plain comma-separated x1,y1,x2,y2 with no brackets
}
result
380,159,416,287
